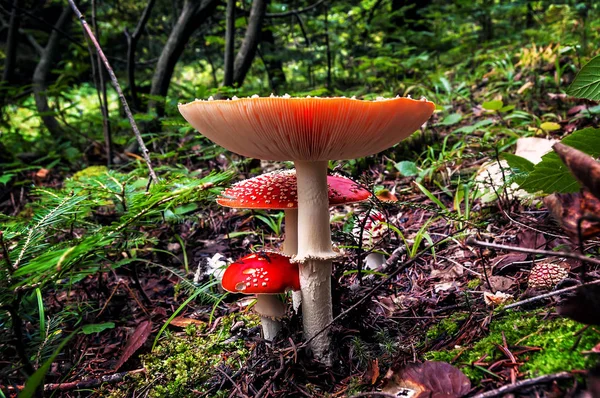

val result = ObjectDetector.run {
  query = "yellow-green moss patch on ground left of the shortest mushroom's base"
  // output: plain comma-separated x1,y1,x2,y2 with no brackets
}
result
142,314,259,398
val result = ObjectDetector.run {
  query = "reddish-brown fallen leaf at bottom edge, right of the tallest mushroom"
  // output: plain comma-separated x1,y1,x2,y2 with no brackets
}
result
383,361,471,398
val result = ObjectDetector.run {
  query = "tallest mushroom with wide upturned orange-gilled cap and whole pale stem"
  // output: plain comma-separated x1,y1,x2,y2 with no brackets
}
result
179,95,435,362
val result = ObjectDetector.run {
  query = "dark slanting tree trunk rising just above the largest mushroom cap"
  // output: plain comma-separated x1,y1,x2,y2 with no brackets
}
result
233,0,268,87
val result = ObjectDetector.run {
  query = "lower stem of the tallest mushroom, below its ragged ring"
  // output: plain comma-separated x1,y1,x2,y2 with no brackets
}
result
300,260,333,362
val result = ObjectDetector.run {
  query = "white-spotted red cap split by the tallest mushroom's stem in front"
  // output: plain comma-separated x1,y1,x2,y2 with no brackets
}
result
217,169,371,210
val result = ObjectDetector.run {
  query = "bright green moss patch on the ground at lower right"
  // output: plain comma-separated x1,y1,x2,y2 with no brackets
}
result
425,311,600,382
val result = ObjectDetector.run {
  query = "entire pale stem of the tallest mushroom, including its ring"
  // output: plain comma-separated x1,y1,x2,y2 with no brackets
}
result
294,161,337,362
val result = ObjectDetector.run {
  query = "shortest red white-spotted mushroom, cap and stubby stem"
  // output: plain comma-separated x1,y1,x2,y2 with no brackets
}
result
221,252,300,341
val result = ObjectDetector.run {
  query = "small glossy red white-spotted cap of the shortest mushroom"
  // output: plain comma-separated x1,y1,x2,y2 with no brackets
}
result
221,252,300,294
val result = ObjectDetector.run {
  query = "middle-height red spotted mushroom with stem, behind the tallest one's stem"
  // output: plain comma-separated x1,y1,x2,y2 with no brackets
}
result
217,169,371,311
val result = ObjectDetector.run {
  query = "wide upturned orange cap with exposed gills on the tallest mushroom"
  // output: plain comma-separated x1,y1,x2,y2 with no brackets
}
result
179,97,435,161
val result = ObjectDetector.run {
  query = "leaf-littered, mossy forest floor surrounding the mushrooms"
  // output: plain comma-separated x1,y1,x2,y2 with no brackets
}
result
0,42,600,397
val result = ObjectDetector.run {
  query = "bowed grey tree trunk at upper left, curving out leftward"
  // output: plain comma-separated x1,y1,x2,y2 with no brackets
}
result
33,7,71,139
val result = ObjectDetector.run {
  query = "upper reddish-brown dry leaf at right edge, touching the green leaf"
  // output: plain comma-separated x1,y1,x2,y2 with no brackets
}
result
553,142,600,199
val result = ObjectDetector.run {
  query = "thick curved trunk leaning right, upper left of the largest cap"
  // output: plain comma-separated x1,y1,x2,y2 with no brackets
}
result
148,0,218,116
